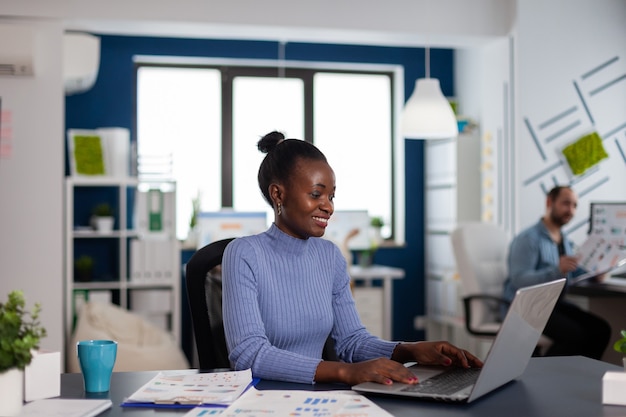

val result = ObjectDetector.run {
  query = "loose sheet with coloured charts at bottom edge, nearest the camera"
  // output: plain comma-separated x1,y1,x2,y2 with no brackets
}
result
221,388,392,417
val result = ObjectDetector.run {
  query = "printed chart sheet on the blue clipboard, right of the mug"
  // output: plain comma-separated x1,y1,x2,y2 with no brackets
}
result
123,369,252,405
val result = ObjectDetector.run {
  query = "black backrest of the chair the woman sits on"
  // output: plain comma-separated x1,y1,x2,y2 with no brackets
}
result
185,238,234,369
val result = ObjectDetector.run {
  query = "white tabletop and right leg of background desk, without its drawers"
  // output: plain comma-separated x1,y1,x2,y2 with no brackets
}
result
350,265,404,340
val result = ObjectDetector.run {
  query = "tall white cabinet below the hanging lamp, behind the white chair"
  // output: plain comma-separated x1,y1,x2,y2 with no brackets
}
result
424,131,481,347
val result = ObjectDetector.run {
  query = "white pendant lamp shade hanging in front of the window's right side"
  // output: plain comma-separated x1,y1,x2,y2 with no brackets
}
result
402,78,459,139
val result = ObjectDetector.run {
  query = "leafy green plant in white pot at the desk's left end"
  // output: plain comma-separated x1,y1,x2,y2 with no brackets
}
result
0,290,46,416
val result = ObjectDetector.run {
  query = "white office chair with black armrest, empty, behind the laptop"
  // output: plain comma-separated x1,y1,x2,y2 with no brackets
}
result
451,222,552,354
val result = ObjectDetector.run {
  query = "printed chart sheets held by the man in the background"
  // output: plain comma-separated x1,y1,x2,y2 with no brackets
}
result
571,234,626,284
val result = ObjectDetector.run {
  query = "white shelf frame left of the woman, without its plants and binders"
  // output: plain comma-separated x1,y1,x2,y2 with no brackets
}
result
65,177,181,344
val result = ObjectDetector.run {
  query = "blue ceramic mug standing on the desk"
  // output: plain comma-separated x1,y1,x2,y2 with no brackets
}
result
76,340,117,392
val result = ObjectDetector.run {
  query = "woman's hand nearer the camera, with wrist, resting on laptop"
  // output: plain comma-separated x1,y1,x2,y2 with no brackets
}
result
315,358,418,385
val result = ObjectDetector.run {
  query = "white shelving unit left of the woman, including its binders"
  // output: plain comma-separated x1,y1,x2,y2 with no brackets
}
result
65,177,181,343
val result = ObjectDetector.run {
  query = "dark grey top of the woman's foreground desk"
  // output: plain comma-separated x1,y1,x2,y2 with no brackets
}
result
61,356,626,417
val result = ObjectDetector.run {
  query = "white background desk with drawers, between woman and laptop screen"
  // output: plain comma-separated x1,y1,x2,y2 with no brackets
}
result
350,265,404,340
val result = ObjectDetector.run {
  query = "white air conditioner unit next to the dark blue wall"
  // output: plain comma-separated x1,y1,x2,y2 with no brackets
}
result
63,33,100,95
